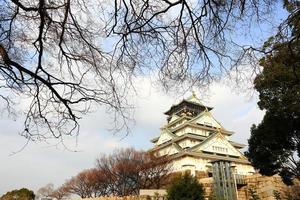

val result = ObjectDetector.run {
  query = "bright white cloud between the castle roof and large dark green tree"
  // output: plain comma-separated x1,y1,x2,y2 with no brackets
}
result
210,82,264,144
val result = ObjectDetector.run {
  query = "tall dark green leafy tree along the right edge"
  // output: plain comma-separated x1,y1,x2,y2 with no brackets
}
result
246,1,300,184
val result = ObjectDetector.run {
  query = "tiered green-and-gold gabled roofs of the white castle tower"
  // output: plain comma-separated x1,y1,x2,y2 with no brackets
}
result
151,93,249,163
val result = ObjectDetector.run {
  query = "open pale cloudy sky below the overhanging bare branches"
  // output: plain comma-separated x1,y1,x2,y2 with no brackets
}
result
0,74,264,196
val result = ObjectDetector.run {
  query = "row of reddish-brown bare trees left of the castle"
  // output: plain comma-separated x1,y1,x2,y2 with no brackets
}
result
37,148,171,200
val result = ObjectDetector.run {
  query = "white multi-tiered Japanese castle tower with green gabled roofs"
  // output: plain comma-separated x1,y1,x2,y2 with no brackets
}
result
151,92,255,177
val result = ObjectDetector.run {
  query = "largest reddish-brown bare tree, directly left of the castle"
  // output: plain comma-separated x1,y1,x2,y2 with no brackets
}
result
97,148,170,196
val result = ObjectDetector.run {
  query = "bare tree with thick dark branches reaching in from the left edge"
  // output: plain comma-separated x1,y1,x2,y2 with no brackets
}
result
0,0,133,140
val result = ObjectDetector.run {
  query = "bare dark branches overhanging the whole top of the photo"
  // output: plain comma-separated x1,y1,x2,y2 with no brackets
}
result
0,0,284,140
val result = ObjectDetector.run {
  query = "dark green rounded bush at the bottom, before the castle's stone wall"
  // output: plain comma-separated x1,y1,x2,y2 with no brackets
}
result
167,173,204,200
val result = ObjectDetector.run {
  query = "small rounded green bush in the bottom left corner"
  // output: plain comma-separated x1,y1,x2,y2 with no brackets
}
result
0,188,35,200
